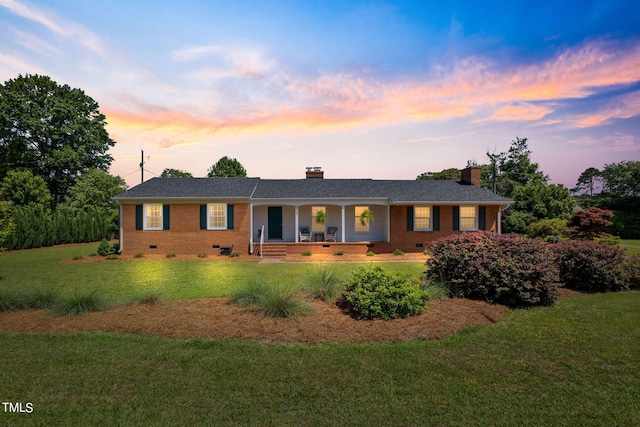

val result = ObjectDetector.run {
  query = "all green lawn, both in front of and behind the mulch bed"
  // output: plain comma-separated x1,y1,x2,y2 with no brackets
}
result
0,242,640,426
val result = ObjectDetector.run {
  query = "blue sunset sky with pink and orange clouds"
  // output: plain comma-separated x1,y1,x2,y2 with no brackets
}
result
0,0,640,188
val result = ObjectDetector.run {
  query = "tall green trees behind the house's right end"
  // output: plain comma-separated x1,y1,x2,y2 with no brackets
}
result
416,137,640,239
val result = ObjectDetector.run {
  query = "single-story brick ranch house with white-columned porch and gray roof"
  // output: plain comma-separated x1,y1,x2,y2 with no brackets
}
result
114,166,513,254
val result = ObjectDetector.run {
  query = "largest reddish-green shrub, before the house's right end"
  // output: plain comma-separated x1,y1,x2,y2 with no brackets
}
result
427,232,559,307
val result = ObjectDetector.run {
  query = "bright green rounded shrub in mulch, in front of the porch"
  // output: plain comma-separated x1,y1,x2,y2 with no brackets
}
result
342,266,429,320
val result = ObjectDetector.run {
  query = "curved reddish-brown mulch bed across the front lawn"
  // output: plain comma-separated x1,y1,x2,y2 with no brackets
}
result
0,298,506,343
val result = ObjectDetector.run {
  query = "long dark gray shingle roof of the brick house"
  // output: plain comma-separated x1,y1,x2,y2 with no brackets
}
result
115,178,511,204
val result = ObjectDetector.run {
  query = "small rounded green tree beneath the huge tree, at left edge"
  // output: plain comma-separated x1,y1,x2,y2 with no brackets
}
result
0,170,51,209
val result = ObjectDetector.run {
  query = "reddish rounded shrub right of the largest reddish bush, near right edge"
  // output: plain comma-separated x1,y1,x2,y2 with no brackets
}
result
555,240,625,292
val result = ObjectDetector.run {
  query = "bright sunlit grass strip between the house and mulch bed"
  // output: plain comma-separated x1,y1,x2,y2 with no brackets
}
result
0,243,425,303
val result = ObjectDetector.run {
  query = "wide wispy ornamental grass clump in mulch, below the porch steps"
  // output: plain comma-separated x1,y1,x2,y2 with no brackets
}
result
231,279,311,317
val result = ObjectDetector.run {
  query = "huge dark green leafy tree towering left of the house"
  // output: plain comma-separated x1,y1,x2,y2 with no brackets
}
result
0,75,115,205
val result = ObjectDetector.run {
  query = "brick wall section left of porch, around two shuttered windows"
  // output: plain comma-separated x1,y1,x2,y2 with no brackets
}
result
122,203,249,255
